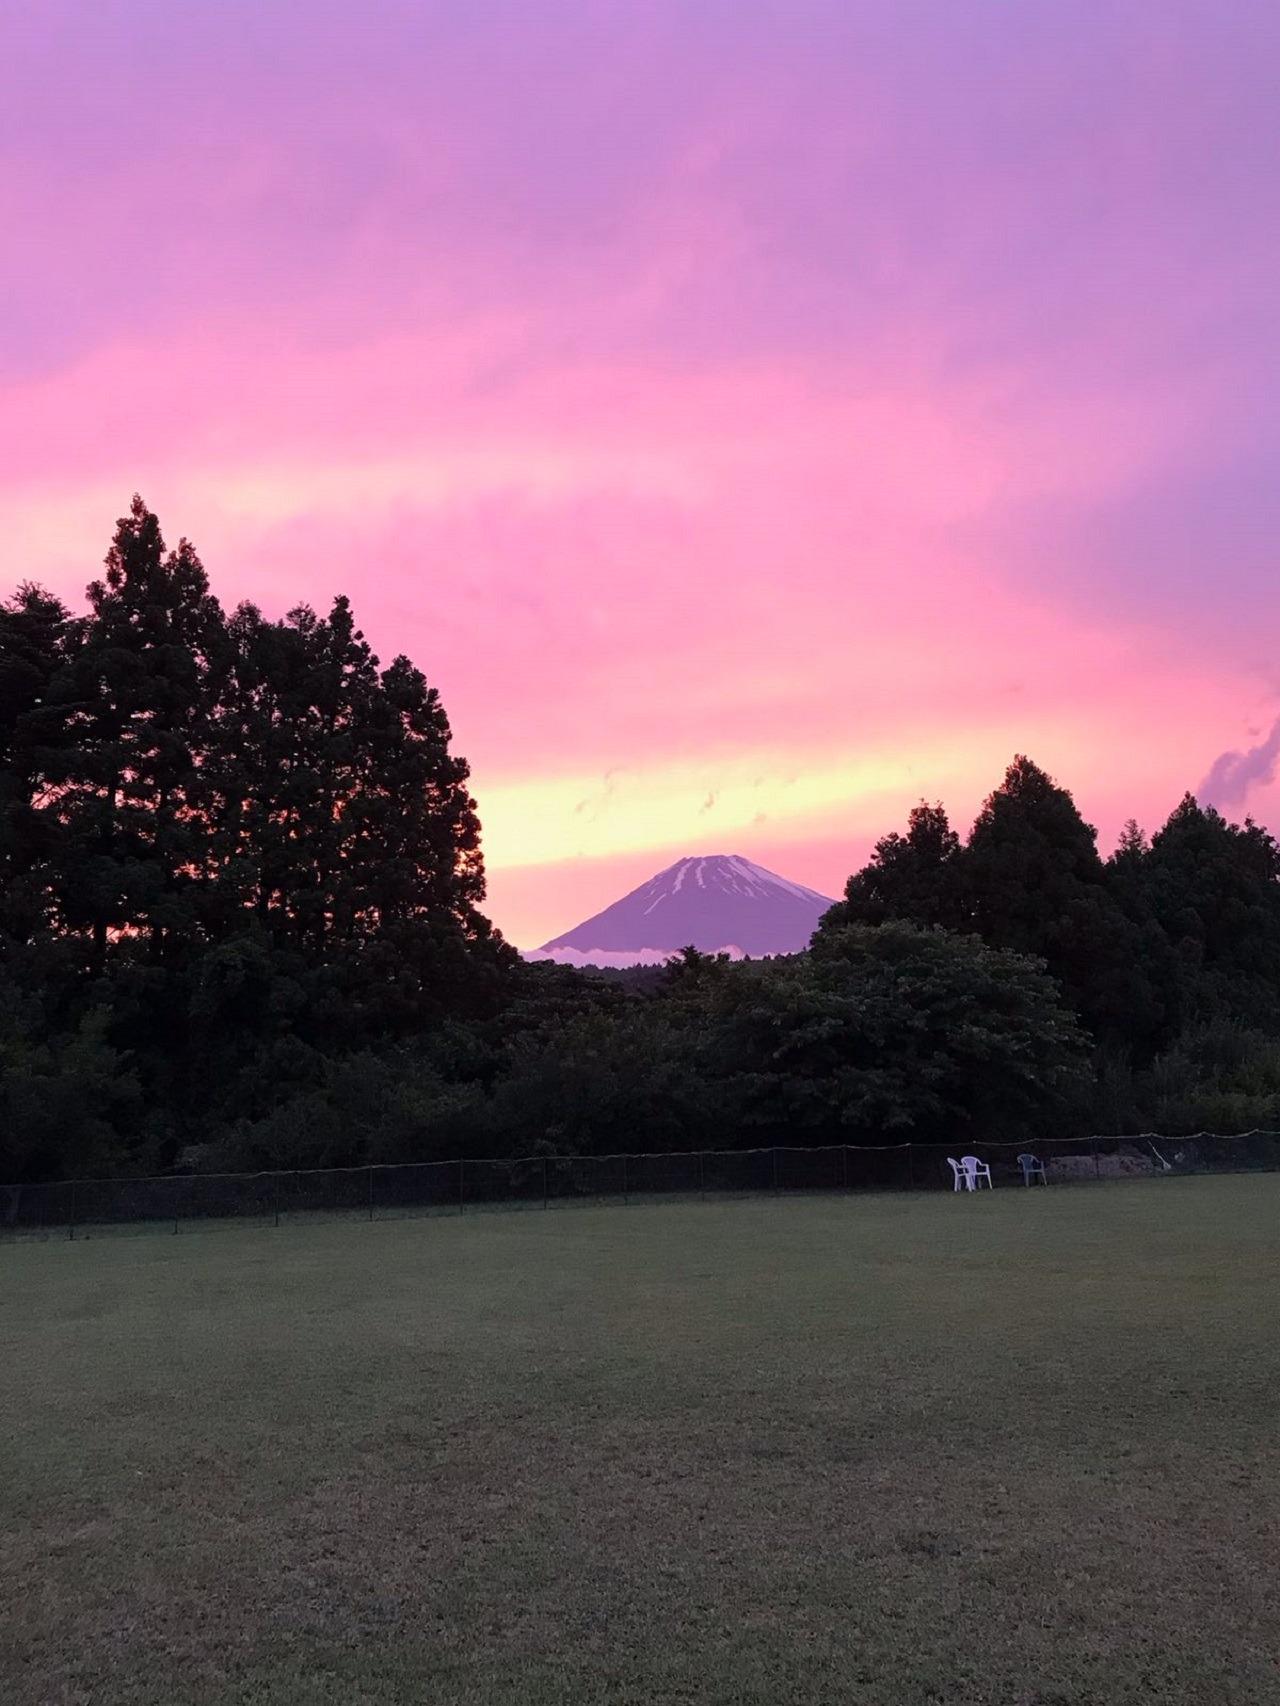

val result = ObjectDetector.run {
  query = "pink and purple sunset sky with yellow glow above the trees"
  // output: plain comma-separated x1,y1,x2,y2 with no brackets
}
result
0,0,1280,947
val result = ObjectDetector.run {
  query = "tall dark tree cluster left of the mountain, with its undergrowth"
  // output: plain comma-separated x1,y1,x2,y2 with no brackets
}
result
0,500,515,1177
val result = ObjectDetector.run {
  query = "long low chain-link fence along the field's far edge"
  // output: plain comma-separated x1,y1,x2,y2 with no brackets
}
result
0,1131,1280,1239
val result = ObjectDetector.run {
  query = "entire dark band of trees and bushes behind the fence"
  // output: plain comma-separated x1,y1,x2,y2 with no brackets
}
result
0,498,1280,1181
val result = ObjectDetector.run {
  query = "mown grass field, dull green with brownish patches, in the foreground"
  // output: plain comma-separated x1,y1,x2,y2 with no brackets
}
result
0,1177,1280,1706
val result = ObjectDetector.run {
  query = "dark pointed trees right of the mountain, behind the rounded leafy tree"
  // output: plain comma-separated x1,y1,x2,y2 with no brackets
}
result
816,757,1280,1131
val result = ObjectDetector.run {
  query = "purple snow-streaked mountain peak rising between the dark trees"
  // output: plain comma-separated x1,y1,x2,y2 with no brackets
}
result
531,853,833,966
